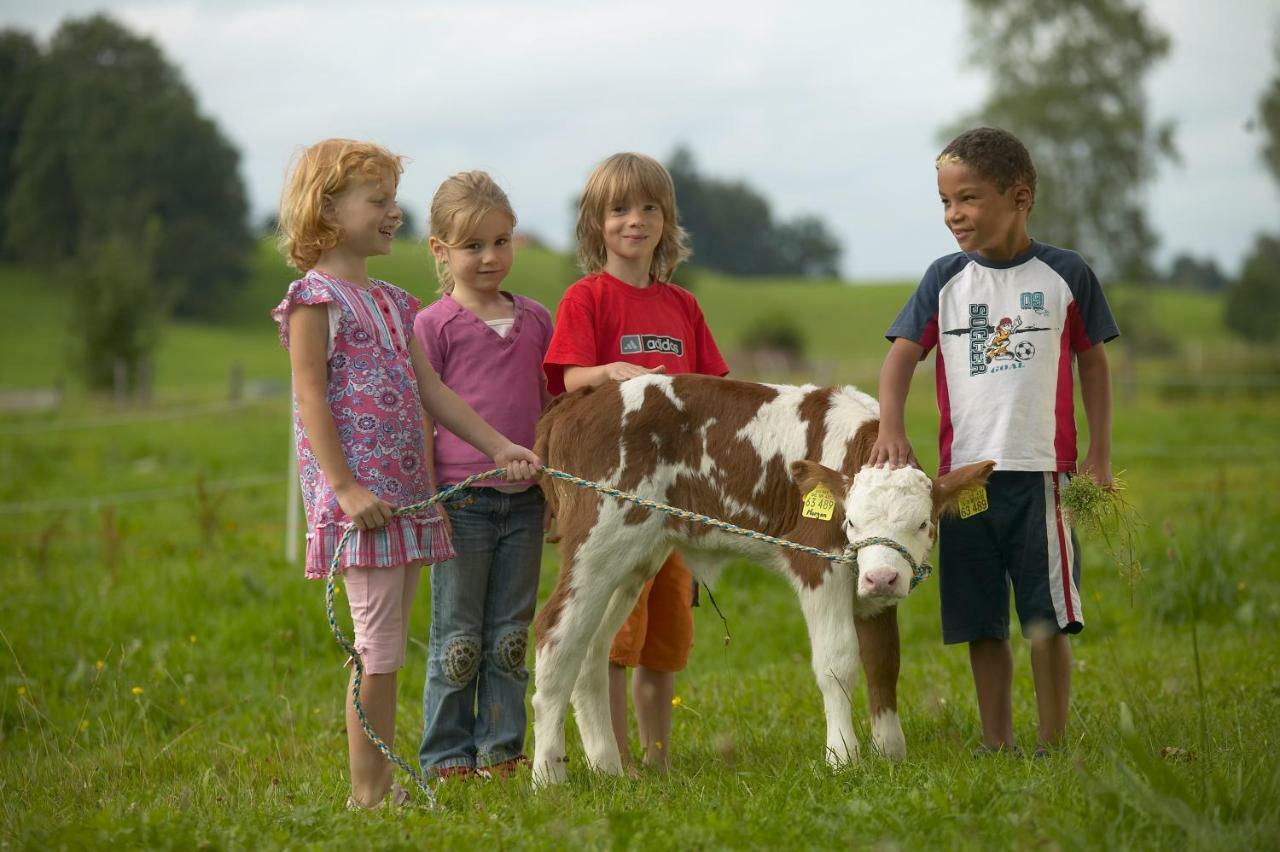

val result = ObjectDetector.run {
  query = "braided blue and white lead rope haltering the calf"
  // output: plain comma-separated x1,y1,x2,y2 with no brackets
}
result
325,466,933,809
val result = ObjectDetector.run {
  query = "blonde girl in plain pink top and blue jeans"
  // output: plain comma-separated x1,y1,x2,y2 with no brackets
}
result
413,171,552,780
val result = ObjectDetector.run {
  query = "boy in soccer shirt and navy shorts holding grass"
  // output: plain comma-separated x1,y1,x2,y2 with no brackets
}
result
869,128,1119,755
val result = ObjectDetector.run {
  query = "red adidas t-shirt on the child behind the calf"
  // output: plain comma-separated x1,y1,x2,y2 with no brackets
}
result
543,272,728,394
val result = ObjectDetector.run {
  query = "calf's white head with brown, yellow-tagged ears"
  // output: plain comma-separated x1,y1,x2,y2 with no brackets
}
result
791,461,996,603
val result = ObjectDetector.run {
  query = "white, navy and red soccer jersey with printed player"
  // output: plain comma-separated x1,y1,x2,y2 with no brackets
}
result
886,242,1120,476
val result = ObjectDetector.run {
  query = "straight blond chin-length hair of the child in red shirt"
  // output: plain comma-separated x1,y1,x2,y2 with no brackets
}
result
577,154,692,281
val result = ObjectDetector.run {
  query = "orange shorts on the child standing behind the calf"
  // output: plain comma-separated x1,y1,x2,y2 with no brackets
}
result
609,551,694,672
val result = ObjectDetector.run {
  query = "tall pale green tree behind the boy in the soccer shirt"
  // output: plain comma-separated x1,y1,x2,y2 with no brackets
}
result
947,0,1176,278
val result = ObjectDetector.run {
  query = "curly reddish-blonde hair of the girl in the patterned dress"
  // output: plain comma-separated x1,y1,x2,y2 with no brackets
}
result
276,139,404,272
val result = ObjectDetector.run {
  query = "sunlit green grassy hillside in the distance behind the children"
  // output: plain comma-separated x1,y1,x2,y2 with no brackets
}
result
0,238,1254,397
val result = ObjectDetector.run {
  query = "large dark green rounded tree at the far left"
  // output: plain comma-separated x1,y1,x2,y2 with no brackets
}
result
5,15,251,315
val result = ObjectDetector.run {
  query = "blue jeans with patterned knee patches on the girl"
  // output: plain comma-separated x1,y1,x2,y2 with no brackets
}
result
417,485,544,773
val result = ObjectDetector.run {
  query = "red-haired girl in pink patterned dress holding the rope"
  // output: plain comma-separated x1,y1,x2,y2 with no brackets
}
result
271,139,539,809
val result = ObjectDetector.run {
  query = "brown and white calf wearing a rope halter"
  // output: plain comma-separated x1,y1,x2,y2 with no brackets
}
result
532,375,992,784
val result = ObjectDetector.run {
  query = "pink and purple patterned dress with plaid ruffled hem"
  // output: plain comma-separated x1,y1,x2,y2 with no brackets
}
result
271,270,454,580
